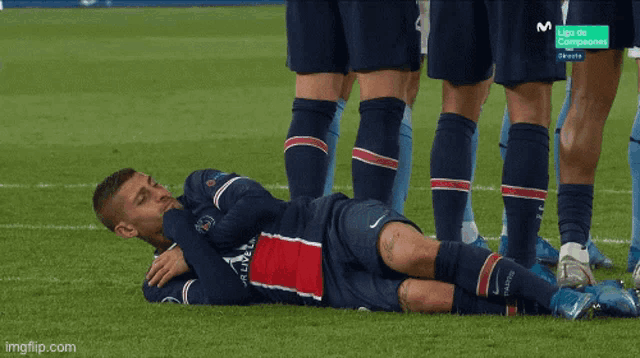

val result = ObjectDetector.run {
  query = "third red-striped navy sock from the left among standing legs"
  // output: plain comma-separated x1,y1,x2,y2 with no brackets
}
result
431,113,476,241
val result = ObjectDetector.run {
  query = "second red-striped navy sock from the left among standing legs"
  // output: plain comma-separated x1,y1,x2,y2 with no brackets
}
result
351,97,405,205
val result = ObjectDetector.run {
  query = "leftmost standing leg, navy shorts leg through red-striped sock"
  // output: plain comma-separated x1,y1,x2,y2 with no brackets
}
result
284,1,348,198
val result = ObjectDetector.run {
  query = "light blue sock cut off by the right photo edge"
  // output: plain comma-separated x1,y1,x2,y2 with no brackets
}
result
629,96,640,249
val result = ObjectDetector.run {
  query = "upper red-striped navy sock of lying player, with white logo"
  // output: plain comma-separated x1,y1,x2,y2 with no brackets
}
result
435,241,558,309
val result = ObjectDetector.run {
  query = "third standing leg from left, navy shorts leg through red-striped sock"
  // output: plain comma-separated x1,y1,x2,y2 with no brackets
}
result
428,0,492,241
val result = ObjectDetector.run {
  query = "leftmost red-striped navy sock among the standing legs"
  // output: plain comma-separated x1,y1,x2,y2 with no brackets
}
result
284,98,337,199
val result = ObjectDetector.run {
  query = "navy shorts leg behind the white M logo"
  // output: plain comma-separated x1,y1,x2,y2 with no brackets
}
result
485,0,565,86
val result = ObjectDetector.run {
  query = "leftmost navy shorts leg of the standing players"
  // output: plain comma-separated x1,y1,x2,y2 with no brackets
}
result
286,0,349,74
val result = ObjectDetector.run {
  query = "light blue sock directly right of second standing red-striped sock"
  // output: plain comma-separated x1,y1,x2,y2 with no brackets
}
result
391,105,413,214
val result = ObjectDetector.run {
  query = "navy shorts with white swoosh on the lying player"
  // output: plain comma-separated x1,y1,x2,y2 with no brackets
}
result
322,200,417,311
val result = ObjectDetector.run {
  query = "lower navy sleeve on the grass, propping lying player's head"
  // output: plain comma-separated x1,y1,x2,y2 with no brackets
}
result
154,209,252,305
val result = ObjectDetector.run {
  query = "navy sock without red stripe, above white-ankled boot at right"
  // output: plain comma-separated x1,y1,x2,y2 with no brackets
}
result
558,184,593,246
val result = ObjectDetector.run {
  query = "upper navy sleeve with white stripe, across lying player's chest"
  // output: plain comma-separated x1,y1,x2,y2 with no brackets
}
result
185,169,285,250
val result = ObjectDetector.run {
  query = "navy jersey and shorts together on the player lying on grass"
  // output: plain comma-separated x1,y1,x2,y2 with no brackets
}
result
143,169,420,311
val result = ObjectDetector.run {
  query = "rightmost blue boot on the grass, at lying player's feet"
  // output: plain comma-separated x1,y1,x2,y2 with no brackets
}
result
583,280,638,317
